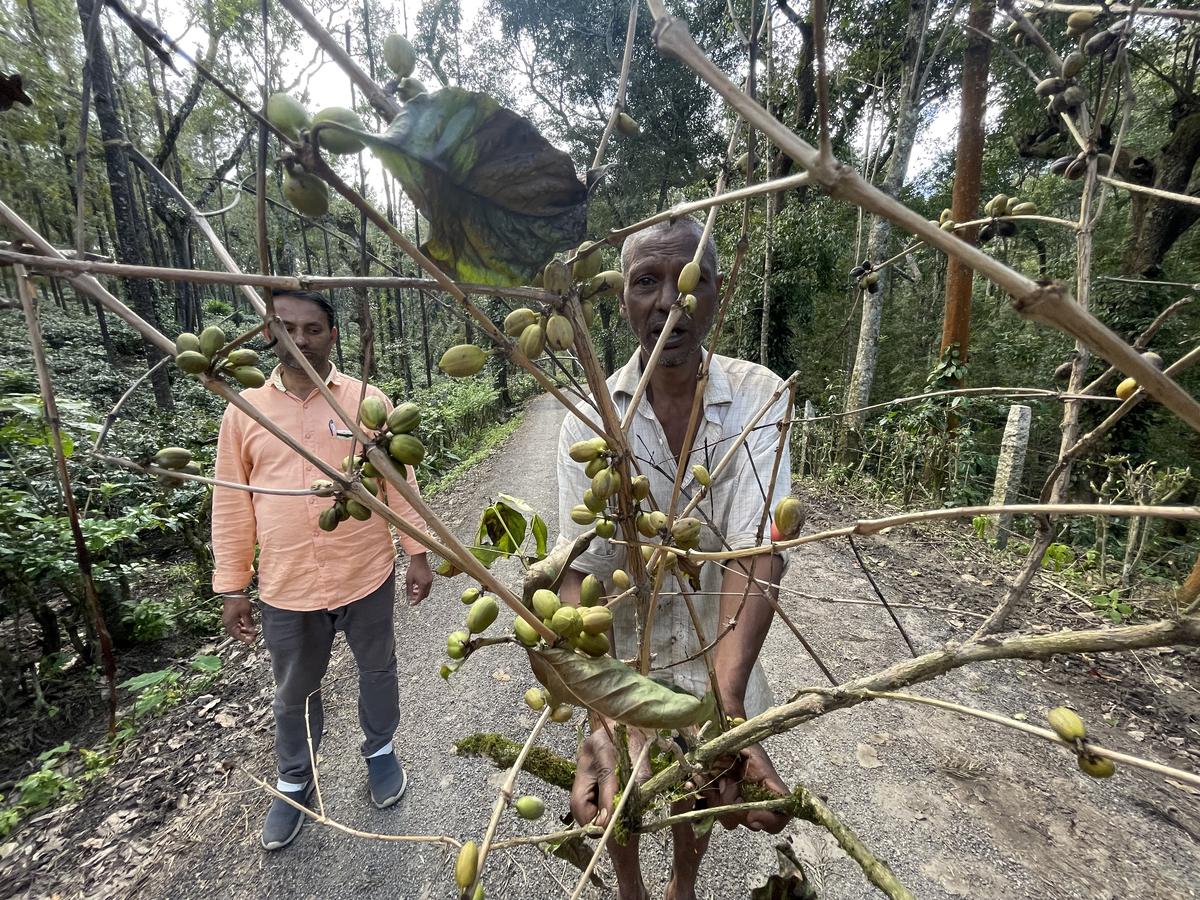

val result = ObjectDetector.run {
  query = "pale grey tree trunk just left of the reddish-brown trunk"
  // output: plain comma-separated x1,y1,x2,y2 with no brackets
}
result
839,0,929,462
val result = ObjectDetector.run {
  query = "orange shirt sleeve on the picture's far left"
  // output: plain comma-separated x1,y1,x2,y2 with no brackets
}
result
212,404,258,594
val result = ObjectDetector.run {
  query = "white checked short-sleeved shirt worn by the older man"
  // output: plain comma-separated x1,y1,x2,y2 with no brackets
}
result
558,352,792,715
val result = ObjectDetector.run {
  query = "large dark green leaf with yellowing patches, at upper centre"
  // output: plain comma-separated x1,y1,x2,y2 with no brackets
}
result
354,88,587,284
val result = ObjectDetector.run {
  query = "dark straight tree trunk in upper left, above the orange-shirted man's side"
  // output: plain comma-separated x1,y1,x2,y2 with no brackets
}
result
76,0,174,409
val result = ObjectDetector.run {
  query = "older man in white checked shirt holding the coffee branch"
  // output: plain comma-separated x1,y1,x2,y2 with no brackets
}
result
558,217,791,900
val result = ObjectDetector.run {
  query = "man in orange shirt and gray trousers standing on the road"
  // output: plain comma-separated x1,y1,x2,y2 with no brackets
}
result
212,292,433,850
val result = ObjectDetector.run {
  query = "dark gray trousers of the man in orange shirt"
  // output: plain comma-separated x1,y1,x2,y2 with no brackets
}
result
263,572,400,784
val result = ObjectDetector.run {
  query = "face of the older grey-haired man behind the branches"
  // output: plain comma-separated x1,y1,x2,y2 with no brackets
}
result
620,228,721,366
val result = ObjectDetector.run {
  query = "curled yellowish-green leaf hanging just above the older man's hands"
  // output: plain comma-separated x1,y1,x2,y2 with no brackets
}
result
529,647,713,728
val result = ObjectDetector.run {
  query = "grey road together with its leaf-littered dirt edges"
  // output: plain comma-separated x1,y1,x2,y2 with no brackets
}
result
0,398,1200,900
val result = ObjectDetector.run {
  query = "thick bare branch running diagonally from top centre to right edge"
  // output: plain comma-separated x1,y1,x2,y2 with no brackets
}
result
647,0,1200,431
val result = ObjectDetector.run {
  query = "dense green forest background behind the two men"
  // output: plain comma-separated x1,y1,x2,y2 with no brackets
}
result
0,0,1200,859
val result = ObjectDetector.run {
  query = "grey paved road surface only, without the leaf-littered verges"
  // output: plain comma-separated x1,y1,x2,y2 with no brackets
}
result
139,398,1198,900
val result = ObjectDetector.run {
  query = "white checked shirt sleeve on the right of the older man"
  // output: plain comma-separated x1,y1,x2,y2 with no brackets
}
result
725,391,792,550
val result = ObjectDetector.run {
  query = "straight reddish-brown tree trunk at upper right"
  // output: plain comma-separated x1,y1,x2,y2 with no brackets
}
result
941,0,1003,376
